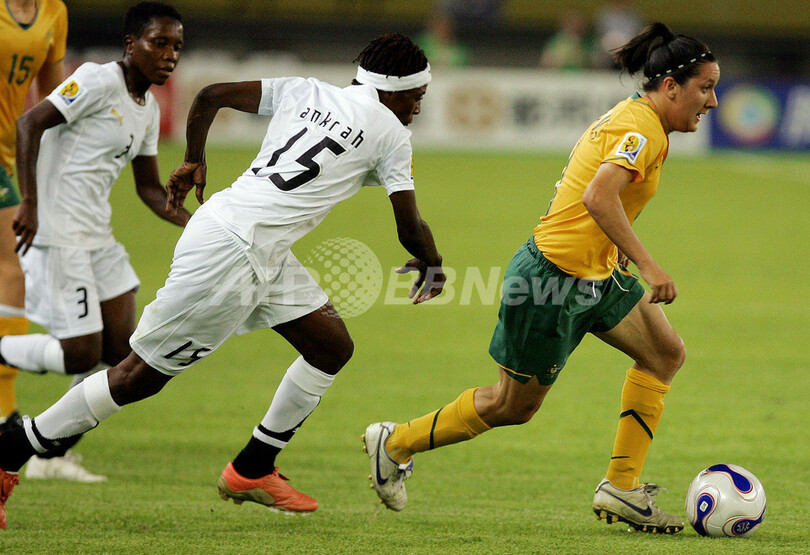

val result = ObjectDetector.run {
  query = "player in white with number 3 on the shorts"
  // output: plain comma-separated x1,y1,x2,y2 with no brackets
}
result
0,2,190,482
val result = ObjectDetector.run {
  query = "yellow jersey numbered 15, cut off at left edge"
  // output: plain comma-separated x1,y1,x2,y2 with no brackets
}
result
0,0,67,175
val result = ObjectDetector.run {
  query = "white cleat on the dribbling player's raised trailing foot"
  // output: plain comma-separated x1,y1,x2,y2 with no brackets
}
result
361,422,413,511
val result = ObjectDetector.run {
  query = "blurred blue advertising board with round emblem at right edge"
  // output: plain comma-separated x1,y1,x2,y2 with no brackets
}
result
711,80,810,150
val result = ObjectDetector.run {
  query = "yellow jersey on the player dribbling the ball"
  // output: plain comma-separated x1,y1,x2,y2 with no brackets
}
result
534,95,669,280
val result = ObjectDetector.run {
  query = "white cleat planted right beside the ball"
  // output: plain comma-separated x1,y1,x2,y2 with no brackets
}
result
593,479,683,534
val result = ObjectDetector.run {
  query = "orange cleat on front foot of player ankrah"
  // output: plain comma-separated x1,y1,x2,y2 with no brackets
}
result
217,463,318,514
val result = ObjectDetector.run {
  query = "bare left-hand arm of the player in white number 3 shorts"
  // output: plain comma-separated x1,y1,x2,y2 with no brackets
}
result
12,100,65,255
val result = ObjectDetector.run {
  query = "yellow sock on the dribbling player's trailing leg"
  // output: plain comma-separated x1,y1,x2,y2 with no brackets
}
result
385,388,490,464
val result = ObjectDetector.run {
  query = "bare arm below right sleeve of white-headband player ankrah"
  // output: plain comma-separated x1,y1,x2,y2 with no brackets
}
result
388,191,447,304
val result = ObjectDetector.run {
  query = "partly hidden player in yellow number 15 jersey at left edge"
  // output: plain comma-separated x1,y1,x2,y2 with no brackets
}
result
0,0,67,430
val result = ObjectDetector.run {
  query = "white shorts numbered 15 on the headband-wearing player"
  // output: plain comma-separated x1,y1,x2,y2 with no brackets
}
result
130,209,329,376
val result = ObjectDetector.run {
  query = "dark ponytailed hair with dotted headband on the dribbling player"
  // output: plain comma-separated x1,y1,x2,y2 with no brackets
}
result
613,22,717,92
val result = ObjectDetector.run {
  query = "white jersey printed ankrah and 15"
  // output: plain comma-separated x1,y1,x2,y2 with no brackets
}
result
206,77,413,279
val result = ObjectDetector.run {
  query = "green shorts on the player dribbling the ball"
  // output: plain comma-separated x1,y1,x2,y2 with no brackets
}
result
489,238,644,385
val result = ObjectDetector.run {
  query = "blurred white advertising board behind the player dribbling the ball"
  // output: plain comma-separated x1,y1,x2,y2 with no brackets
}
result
413,69,709,154
